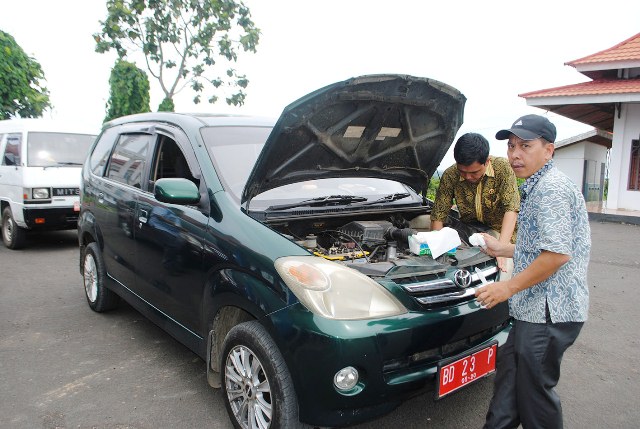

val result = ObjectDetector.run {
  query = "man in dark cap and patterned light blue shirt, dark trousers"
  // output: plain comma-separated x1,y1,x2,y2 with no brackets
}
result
476,115,591,428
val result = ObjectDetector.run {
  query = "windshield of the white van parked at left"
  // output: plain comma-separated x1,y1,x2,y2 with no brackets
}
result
27,132,96,167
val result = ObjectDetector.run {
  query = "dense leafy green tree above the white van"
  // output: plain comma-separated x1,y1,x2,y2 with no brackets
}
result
0,30,51,119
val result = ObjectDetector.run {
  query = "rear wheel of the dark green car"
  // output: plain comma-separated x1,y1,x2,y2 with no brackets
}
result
82,243,120,313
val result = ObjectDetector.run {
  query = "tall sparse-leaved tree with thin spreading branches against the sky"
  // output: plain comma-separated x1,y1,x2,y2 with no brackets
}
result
94,0,260,110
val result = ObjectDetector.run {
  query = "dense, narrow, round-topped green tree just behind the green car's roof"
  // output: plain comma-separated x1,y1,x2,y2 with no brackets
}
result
104,60,150,122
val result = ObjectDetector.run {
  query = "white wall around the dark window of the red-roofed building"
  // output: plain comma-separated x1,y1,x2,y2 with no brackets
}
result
607,104,640,210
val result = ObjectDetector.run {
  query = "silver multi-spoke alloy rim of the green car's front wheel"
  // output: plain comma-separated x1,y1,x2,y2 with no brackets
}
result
224,345,273,429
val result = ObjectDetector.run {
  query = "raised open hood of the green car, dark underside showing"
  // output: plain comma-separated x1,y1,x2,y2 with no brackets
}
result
242,75,466,204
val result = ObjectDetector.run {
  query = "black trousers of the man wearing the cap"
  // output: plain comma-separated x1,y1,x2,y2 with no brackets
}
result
484,313,584,429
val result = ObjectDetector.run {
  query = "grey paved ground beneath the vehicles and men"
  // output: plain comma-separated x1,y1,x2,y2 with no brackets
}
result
0,221,640,429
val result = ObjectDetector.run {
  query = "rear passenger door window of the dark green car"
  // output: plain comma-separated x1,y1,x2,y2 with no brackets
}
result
107,134,153,188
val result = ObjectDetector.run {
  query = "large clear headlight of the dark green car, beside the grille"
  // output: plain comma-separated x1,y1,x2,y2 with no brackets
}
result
275,256,407,320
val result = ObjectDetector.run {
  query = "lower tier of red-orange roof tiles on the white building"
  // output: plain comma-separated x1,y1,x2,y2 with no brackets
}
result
518,78,640,98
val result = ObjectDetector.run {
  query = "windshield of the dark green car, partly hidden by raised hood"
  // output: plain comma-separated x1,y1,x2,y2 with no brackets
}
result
202,126,415,210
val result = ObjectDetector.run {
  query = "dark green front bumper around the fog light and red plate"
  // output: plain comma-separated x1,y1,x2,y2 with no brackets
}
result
272,300,511,426
